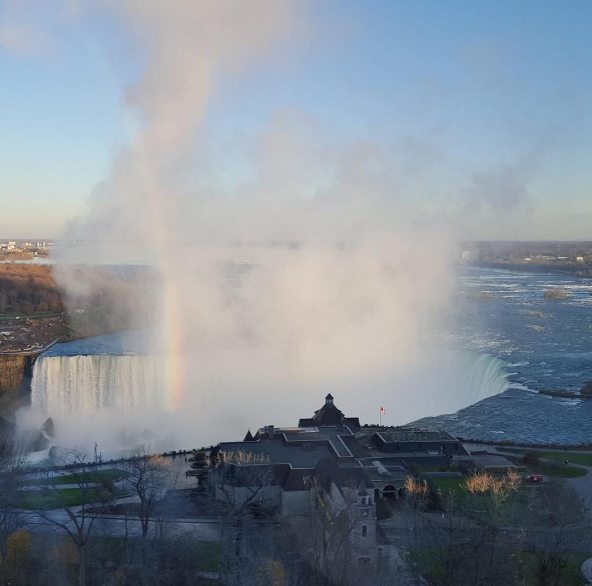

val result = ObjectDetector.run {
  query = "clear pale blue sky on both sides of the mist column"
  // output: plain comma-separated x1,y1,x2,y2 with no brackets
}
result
0,0,592,238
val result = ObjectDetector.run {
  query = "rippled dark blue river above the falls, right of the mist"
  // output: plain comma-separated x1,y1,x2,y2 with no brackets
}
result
414,268,592,444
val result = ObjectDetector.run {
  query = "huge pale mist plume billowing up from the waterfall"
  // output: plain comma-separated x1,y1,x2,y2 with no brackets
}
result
39,0,462,448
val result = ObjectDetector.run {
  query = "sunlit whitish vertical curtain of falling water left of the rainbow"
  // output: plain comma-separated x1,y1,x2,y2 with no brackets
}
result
31,354,165,416
